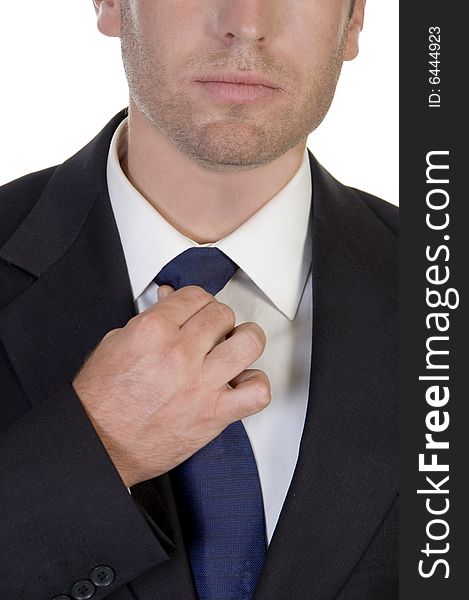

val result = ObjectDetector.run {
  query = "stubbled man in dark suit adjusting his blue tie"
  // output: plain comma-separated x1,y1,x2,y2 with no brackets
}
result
0,0,398,600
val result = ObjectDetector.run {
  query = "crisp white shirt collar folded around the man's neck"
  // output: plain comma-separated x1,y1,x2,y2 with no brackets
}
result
107,119,312,320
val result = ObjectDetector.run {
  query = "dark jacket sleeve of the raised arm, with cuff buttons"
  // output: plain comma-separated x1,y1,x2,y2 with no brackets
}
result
0,384,172,600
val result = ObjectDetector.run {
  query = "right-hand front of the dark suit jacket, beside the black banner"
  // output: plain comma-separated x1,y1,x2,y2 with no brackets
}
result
255,159,398,600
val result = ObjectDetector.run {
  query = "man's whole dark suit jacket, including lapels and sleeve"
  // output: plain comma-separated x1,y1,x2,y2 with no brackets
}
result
0,111,398,600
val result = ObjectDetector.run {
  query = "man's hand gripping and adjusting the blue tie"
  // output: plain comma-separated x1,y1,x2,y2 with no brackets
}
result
73,286,270,487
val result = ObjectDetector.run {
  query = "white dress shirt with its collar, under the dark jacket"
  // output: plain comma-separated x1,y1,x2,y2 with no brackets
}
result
107,119,312,543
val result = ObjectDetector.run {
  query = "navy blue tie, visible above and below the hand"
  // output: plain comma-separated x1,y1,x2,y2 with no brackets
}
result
155,247,266,600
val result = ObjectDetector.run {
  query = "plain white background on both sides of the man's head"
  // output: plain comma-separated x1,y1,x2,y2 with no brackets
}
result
0,0,399,204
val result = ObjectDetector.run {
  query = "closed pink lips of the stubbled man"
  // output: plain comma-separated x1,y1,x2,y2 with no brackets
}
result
194,72,281,104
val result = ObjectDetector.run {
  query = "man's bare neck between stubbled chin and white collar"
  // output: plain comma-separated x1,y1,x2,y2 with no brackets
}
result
121,102,306,244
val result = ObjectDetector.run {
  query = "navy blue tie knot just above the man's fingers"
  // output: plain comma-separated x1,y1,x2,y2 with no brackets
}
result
155,247,238,295
